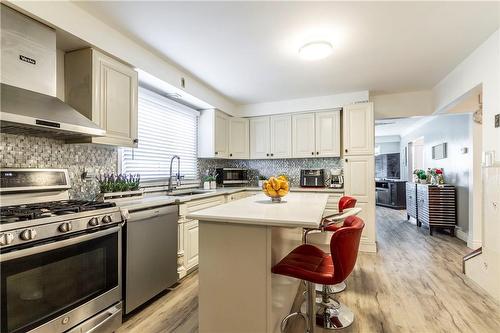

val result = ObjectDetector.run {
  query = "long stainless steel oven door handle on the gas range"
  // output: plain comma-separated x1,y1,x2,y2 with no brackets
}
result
0,226,121,262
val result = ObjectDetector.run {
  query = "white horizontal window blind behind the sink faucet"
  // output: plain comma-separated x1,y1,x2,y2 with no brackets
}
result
121,87,199,180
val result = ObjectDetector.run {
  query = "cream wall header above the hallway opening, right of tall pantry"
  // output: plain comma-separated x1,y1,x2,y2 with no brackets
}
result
370,90,434,119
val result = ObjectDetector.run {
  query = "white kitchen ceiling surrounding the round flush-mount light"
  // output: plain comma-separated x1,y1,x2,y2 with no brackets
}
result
75,1,500,104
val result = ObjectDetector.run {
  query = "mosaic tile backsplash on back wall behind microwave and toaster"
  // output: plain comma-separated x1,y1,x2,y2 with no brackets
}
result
198,157,342,186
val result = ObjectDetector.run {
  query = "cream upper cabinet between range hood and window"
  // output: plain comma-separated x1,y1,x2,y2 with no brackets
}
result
65,49,138,147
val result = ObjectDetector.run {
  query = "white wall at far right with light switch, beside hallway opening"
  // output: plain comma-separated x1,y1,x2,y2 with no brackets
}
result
433,30,500,301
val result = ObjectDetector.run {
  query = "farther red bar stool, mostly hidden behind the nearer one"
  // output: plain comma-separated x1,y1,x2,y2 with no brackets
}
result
304,195,357,295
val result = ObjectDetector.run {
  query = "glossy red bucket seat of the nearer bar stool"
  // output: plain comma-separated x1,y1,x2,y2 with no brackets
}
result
272,216,365,285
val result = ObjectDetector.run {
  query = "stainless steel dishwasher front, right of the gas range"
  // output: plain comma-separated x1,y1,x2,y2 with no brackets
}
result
124,205,179,314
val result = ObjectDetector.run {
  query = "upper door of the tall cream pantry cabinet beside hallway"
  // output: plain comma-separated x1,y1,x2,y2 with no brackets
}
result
343,103,374,156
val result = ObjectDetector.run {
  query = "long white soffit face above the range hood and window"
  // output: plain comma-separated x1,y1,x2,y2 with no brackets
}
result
8,1,235,114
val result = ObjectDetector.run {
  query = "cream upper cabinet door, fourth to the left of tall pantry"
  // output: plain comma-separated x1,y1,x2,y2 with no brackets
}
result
250,117,271,159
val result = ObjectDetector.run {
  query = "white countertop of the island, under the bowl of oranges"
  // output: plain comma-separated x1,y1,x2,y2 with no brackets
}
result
187,192,328,228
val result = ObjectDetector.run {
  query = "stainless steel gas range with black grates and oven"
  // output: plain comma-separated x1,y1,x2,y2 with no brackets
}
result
0,169,123,333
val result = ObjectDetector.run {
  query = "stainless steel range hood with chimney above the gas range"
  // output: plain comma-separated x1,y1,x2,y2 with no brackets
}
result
0,4,106,139
